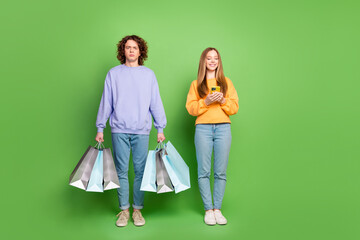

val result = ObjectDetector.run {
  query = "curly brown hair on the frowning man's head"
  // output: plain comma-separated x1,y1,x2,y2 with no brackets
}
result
117,35,147,65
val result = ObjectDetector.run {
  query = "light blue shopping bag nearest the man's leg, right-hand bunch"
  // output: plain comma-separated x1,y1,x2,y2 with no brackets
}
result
140,150,156,192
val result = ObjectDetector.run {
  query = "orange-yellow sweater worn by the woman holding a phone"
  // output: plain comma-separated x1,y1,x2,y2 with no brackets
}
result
186,78,239,124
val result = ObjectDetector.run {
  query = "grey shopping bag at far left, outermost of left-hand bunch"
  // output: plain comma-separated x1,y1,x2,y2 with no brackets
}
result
69,144,99,190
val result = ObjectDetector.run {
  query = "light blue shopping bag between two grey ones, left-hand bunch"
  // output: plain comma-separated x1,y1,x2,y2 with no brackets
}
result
86,149,104,192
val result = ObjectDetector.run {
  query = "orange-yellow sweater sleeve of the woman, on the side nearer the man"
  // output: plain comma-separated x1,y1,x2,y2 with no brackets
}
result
186,81,209,116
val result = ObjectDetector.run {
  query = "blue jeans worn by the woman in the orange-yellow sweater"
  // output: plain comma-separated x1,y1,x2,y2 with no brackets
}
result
195,123,231,210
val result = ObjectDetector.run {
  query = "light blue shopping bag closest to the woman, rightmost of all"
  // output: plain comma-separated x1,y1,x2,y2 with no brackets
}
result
163,141,190,193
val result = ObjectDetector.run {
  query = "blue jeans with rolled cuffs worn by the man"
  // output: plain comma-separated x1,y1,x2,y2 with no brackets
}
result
111,133,149,210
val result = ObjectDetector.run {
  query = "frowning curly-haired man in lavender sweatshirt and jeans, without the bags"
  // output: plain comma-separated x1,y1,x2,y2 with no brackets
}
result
95,35,166,227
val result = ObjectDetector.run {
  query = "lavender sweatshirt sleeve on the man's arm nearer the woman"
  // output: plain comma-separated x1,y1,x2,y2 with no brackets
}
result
150,74,166,133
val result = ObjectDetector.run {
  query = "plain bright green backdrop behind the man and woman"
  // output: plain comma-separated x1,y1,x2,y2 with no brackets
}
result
0,0,360,240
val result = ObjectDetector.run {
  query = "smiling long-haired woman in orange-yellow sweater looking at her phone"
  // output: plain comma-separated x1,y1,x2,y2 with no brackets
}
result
186,48,239,225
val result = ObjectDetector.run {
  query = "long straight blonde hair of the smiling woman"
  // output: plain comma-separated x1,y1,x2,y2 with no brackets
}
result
197,47,227,98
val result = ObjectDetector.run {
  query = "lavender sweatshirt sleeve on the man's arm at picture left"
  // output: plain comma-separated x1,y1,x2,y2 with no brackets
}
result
96,72,113,132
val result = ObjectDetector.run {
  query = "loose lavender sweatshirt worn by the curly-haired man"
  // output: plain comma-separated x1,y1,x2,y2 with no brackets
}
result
96,64,166,134
